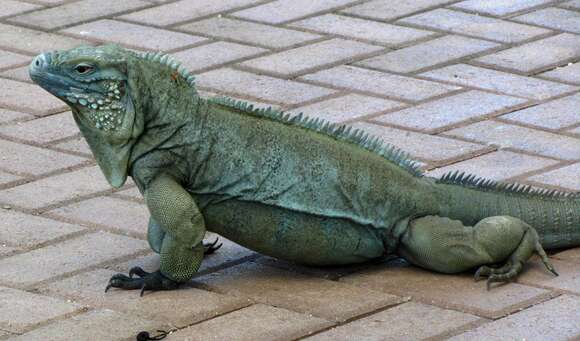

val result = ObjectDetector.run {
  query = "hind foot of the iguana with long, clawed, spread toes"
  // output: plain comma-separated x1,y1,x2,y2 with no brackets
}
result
474,228,558,290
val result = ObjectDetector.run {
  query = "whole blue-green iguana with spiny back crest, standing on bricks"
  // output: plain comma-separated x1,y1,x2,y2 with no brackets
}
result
30,45,580,290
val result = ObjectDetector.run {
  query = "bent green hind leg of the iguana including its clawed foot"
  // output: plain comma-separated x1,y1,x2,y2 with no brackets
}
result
398,216,557,288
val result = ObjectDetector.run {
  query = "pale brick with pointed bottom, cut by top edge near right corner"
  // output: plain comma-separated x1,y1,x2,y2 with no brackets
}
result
450,0,552,17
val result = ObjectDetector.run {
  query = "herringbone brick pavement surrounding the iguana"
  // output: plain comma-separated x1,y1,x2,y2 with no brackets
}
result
0,0,580,340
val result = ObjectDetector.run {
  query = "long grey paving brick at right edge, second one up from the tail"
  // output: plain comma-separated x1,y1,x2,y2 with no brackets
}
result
445,121,580,159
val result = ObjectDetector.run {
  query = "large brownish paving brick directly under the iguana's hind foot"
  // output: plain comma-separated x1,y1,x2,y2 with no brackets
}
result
340,266,550,319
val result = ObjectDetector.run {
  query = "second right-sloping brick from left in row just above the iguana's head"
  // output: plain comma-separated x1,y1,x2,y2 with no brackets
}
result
178,17,321,48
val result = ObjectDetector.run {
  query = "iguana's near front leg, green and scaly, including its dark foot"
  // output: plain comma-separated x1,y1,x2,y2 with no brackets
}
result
107,175,205,294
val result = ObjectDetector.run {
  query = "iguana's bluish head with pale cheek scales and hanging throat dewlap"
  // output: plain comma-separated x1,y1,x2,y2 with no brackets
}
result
29,45,143,187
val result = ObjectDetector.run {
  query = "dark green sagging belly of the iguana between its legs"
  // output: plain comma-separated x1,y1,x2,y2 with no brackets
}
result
202,200,385,265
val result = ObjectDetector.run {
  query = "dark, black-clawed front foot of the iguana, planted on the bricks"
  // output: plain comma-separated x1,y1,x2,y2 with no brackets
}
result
105,266,179,296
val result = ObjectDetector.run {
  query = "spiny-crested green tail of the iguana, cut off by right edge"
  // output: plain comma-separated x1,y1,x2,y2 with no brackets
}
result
437,172,580,249
